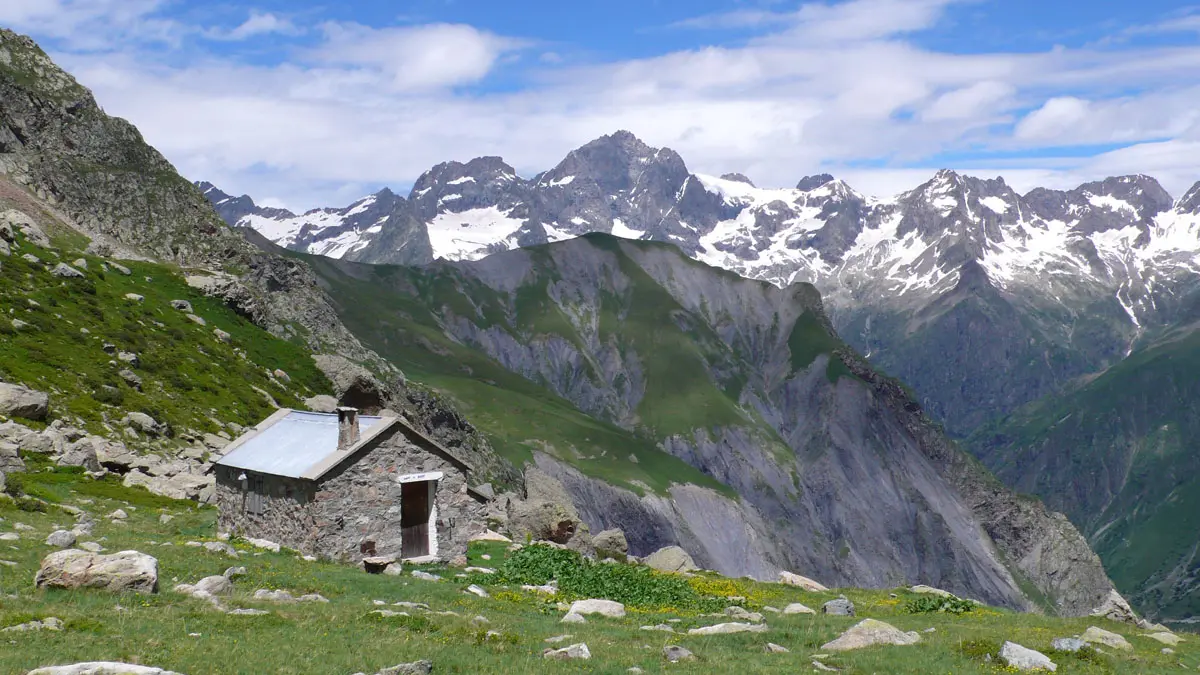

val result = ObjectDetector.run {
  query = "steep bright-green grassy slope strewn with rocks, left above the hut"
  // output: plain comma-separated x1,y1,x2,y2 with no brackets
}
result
0,228,330,432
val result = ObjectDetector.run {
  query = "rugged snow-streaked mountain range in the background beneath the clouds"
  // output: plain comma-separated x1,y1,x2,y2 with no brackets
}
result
199,132,1200,616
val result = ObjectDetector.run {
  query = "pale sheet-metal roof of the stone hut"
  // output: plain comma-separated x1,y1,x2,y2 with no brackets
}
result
216,411,383,478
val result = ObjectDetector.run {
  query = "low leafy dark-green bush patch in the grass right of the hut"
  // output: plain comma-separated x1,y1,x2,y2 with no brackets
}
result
475,544,730,611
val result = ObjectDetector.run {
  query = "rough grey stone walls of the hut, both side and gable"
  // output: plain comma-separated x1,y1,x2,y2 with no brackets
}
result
215,428,486,562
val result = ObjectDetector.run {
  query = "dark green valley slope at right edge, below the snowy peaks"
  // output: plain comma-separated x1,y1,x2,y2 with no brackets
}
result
972,331,1200,616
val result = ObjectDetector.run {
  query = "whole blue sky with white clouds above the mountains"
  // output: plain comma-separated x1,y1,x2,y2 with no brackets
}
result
0,0,1200,209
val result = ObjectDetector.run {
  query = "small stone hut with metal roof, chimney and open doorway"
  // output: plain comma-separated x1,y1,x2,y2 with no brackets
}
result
212,407,486,561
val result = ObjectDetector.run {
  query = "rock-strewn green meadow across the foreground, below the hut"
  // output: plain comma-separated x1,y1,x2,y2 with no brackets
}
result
0,470,1200,675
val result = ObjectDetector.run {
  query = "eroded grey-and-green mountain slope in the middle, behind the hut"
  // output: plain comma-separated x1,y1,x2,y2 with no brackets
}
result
297,234,1108,614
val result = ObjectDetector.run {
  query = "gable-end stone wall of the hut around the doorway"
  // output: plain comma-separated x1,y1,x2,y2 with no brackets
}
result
310,428,485,561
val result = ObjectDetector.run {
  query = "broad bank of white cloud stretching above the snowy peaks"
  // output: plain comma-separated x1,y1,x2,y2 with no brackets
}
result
23,0,1200,209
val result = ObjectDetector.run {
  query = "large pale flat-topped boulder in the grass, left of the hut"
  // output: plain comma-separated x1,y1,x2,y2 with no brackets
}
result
34,549,158,593
